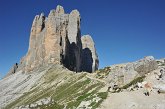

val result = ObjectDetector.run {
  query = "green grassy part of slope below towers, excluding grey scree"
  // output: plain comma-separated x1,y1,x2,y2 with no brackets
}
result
5,65,107,109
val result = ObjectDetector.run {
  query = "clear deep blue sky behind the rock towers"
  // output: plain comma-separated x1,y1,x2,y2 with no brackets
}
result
0,0,165,77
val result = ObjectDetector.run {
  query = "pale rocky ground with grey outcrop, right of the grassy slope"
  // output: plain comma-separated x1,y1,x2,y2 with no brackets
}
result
96,56,165,109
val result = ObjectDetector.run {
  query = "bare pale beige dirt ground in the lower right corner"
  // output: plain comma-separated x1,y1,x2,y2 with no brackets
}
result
100,90,165,109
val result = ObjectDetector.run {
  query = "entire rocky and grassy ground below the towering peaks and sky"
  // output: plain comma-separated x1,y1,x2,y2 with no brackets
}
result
0,57,165,109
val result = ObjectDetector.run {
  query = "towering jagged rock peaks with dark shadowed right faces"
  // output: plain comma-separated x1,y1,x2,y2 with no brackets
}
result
13,5,99,72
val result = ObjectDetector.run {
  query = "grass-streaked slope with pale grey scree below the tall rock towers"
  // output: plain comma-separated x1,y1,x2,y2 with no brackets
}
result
0,65,107,109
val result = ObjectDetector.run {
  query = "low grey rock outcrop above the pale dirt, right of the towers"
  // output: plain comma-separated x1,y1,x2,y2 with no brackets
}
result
107,56,158,87
